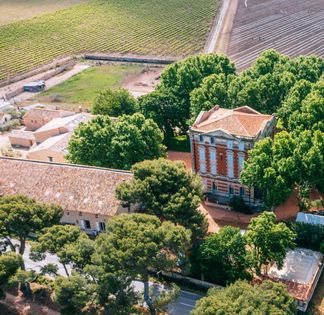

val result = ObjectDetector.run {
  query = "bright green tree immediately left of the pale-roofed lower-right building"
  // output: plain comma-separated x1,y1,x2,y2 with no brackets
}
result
244,212,296,274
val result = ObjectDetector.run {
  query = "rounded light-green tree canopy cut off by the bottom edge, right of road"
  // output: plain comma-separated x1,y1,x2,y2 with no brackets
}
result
191,280,297,315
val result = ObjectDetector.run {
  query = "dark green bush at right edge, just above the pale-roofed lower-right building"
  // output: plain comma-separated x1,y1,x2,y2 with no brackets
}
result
290,222,324,251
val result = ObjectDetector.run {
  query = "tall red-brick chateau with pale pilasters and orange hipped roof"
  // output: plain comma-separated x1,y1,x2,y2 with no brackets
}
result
189,106,276,205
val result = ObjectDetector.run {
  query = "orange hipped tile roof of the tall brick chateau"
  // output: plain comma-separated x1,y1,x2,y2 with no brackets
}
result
192,106,274,137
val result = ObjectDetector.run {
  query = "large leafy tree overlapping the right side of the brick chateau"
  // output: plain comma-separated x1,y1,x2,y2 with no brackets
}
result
241,130,324,207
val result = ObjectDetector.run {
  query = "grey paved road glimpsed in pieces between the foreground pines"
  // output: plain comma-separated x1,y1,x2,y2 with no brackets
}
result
14,241,203,315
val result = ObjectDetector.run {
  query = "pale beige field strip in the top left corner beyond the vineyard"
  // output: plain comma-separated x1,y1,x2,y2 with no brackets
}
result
0,0,87,25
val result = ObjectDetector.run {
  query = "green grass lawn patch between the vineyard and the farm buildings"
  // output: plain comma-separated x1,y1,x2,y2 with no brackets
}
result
35,65,144,108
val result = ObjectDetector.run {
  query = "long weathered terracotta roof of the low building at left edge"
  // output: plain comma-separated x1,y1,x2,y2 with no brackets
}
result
0,158,133,216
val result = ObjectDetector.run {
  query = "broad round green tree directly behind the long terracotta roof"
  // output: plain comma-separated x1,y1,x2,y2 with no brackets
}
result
68,114,165,169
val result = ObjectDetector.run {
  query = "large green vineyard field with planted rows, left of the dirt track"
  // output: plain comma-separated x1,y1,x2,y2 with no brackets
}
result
0,0,219,81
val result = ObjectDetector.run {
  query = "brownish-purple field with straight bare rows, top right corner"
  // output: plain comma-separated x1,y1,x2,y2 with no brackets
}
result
227,0,324,70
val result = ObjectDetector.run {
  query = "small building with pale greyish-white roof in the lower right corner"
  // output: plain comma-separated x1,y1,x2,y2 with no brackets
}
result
267,248,323,312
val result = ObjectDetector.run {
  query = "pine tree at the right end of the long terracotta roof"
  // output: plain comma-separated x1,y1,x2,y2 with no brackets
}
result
116,159,207,239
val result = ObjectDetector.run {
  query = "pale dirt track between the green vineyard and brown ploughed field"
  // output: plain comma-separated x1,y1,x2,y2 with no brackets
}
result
205,0,239,53
